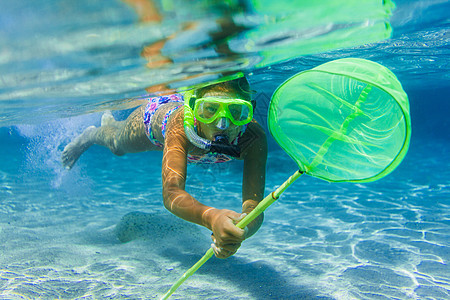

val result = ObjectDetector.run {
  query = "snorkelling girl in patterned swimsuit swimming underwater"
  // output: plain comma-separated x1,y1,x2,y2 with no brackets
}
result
62,77,267,258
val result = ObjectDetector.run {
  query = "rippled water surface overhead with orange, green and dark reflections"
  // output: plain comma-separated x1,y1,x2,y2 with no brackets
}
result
0,0,393,125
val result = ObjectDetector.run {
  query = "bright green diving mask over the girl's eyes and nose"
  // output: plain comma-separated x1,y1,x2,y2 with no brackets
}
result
194,97,253,126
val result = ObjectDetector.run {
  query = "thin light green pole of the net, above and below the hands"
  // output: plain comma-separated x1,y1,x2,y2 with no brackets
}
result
161,171,303,300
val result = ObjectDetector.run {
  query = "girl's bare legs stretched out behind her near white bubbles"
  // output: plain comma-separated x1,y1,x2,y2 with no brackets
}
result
61,105,160,169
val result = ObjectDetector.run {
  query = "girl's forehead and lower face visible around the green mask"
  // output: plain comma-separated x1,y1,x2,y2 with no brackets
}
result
197,90,242,143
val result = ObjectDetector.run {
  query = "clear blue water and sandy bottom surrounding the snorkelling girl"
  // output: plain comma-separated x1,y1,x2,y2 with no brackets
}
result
0,1,450,299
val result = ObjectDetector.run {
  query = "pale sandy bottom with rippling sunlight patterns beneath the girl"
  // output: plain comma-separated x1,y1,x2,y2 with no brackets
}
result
0,135,450,299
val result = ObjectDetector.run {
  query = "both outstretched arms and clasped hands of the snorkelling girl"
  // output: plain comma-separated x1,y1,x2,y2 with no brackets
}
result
162,111,267,258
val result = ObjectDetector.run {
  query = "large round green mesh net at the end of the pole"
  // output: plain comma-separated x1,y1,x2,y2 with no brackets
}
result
268,58,411,182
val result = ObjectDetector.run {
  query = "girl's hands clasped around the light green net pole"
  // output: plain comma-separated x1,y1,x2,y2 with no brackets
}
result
209,209,247,258
